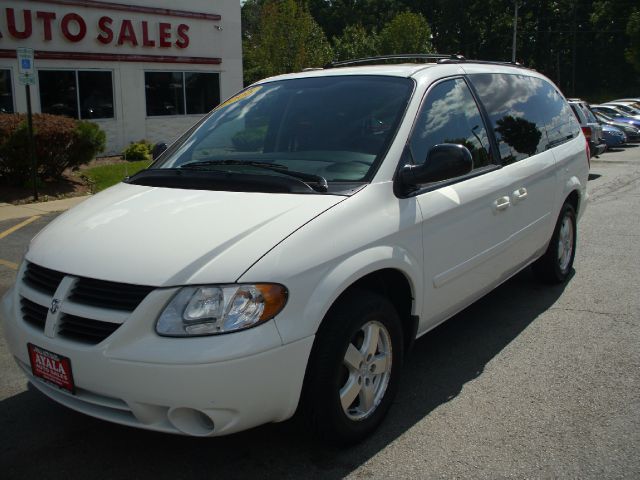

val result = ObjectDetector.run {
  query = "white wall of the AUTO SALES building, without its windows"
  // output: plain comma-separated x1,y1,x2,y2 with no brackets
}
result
0,0,242,154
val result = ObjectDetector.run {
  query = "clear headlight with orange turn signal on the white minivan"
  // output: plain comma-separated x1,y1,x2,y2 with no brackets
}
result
156,283,288,337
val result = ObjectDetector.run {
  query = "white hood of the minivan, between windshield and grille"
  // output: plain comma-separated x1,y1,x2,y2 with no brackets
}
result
26,183,345,286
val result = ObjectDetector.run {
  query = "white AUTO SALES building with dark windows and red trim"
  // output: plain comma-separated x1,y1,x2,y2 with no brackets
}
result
0,0,242,153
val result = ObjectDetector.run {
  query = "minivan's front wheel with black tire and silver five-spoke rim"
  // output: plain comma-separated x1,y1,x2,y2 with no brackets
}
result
301,291,403,445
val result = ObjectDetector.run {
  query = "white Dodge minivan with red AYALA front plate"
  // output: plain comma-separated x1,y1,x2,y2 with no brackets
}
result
0,56,588,443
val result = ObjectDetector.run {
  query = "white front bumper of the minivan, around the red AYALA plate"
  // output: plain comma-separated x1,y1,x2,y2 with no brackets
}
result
0,284,314,436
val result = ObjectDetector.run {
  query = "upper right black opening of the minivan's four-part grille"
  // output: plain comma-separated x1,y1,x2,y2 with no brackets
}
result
69,278,153,312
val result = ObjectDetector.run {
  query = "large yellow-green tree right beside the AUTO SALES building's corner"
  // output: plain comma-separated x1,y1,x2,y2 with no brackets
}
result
239,0,333,83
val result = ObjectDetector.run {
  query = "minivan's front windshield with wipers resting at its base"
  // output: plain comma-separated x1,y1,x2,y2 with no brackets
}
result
152,75,413,182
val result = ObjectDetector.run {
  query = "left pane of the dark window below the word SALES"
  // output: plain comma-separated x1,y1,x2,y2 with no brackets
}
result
144,72,184,117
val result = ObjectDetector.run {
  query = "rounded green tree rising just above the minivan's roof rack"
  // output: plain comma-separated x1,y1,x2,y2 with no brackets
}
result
380,12,433,55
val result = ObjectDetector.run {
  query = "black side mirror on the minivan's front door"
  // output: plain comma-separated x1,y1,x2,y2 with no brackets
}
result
400,143,473,187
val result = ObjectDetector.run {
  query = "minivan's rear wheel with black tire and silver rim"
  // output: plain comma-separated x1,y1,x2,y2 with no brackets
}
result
533,203,577,283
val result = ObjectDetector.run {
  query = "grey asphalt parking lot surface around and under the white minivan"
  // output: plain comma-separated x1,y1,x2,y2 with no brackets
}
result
0,144,640,479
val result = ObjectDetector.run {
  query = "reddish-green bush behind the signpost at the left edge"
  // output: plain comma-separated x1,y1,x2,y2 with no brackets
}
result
0,113,106,186
